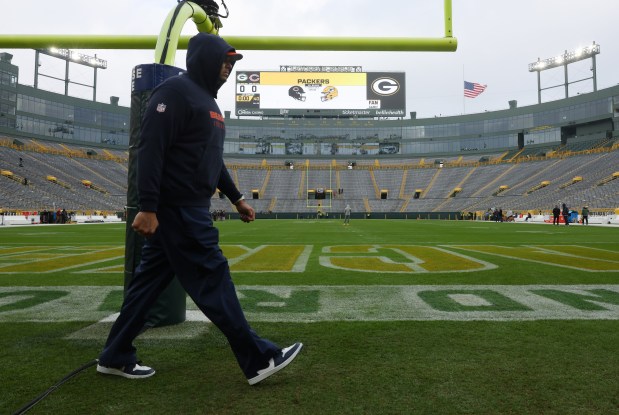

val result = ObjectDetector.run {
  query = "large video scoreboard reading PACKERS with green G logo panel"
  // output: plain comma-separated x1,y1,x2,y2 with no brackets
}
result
235,71,406,117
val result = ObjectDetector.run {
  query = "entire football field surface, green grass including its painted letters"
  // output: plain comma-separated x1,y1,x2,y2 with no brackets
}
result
0,220,619,414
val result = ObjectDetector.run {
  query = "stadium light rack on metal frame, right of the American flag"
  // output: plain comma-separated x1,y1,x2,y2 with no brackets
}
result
529,42,600,104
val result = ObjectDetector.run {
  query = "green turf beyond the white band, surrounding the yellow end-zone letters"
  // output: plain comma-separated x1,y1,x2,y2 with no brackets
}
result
0,220,619,286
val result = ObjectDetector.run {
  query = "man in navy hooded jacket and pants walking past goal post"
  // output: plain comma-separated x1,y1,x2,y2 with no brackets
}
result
97,33,303,385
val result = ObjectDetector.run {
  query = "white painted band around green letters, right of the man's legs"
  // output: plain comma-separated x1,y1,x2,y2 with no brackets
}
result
238,285,619,322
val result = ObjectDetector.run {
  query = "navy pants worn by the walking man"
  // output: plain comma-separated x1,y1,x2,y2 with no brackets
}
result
99,206,280,377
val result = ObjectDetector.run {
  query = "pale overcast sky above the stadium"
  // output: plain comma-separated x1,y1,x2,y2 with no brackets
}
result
0,0,619,118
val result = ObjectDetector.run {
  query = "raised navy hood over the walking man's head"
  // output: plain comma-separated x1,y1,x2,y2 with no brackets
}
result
187,33,236,98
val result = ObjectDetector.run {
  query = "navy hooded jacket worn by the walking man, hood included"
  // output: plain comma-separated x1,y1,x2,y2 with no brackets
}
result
137,33,241,212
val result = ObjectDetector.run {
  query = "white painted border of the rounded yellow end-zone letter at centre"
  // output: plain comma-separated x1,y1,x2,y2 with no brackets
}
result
318,244,497,274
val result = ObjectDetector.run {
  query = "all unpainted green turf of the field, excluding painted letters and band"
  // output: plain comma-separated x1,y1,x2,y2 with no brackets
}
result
0,220,619,414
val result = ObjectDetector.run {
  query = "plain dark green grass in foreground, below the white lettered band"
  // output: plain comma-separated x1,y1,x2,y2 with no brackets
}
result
0,321,619,414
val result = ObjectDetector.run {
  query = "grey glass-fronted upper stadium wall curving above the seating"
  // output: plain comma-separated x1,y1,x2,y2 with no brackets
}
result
0,54,619,158
